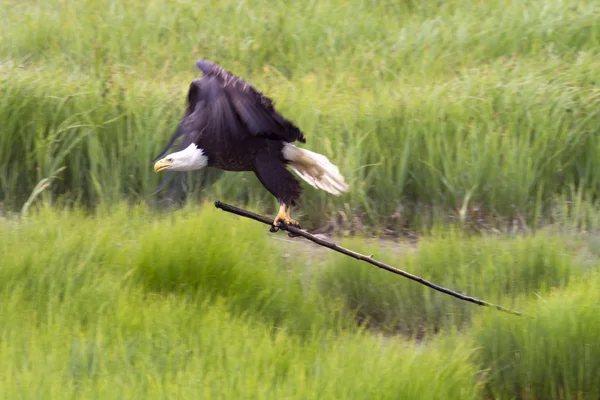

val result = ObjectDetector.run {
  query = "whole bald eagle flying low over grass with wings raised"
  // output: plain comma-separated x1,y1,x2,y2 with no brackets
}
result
154,59,349,230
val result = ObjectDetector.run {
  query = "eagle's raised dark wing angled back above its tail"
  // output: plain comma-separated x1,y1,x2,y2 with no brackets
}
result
196,60,306,143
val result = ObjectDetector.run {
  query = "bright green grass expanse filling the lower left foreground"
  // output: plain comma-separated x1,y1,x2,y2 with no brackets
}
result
0,207,488,399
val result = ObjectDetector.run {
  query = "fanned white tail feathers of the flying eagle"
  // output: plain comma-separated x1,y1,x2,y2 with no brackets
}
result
282,143,350,196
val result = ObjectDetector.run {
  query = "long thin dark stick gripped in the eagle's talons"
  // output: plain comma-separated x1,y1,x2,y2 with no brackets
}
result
215,201,523,316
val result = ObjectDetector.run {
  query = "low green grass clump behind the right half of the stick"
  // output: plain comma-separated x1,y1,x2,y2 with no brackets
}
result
320,230,590,337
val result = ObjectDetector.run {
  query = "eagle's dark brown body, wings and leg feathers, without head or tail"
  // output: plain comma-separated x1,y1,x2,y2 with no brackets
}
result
156,60,306,206
